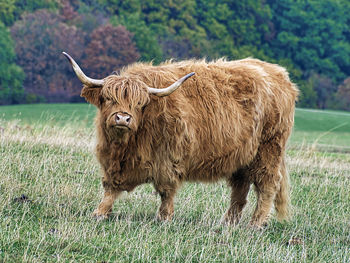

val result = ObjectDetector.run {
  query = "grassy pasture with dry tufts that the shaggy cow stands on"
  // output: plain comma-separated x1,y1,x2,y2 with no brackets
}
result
0,104,350,262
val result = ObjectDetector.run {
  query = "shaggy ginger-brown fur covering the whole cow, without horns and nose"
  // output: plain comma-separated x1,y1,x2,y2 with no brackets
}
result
81,58,298,227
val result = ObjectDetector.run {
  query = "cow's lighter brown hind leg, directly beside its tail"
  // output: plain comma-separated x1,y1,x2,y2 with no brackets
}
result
250,137,284,228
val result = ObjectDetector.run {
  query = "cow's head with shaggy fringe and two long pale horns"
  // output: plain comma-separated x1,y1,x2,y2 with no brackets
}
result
63,52,194,137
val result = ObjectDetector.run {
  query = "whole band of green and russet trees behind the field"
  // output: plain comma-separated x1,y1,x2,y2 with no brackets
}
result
0,0,350,110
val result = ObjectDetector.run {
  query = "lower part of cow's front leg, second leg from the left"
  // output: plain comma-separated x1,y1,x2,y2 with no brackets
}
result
155,184,177,221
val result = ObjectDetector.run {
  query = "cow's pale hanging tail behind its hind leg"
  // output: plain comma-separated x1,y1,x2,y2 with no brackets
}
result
275,158,290,221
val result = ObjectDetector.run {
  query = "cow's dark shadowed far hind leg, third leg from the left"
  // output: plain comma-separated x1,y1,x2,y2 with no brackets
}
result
225,169,250,225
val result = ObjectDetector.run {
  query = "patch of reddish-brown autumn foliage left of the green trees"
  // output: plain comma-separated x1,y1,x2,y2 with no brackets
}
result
11,6,139,102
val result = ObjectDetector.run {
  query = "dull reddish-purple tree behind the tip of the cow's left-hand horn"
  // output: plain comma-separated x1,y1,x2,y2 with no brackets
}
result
11,10,84,102
